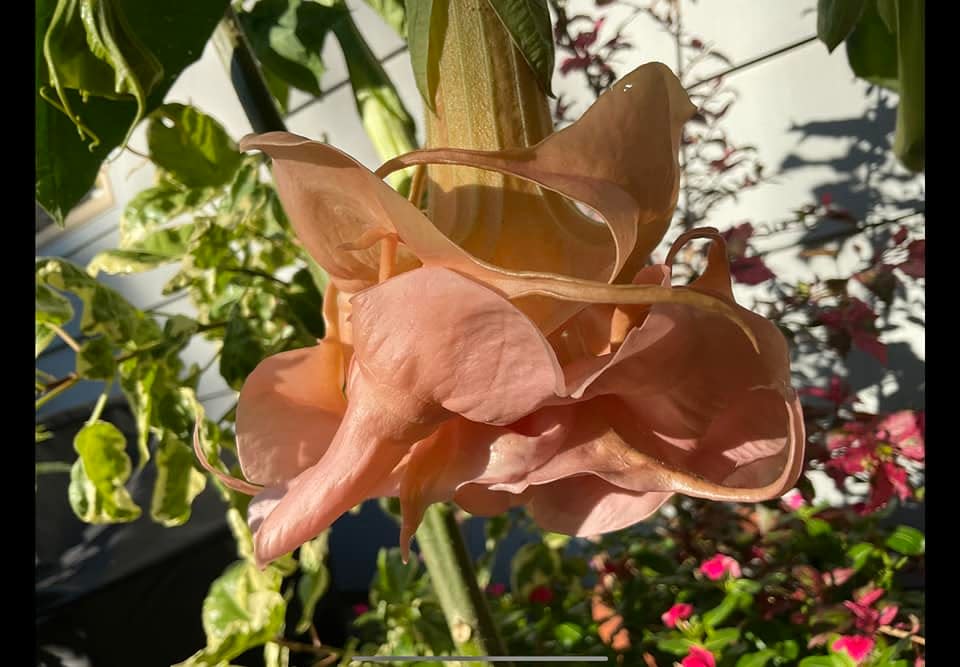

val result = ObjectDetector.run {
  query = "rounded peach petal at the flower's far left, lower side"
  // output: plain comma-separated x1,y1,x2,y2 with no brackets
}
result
237,339,347,486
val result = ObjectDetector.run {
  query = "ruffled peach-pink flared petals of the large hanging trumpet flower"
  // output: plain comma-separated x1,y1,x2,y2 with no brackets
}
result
199,64,804,563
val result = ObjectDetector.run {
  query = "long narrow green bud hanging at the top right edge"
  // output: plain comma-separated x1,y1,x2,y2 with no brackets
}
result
893,0,926,172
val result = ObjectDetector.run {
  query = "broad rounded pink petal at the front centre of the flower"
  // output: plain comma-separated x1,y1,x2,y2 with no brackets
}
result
351,268,563,424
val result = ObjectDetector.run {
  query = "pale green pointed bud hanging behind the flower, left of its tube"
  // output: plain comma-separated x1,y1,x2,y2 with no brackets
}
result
334,14,417,194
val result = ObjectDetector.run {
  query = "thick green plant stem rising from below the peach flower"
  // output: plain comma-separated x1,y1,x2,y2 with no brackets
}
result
417,503,509,665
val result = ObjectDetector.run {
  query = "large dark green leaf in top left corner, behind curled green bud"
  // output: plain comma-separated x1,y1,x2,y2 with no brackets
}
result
34,0,228,224
